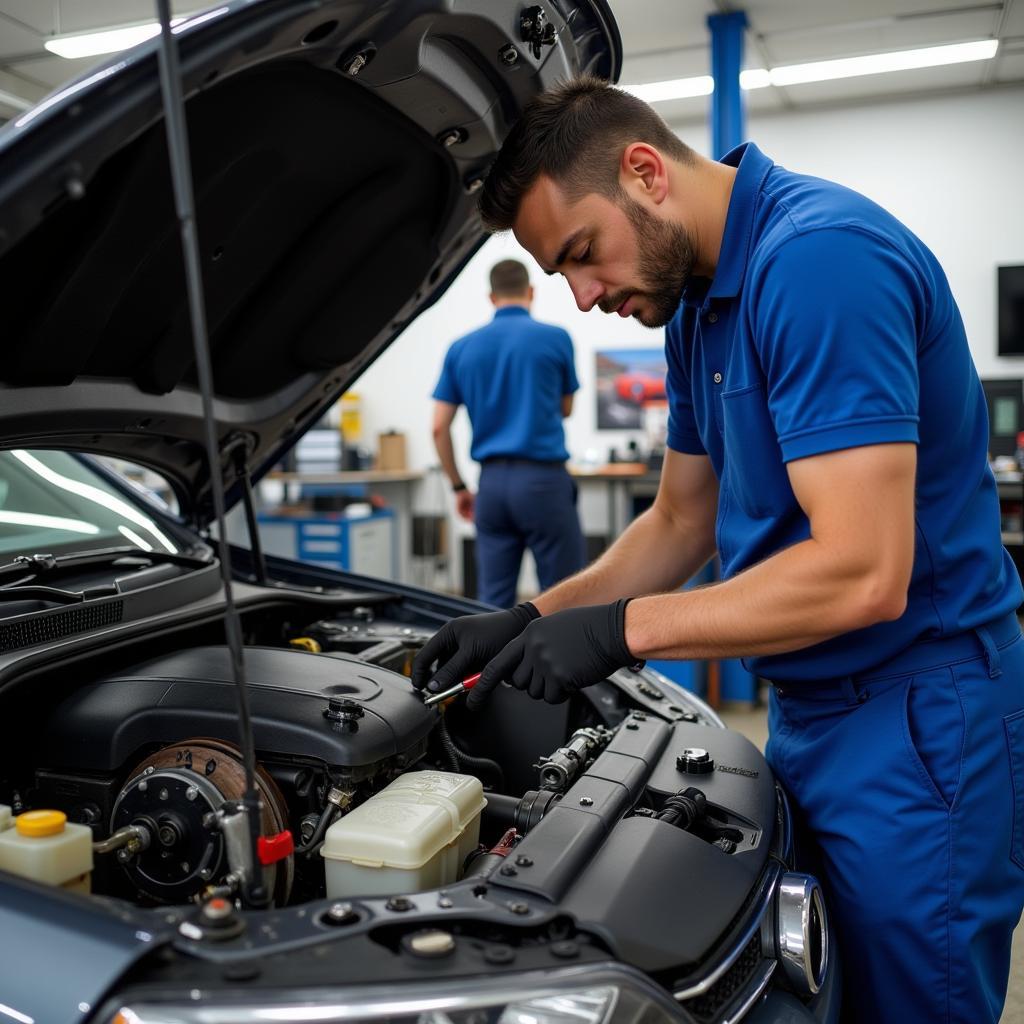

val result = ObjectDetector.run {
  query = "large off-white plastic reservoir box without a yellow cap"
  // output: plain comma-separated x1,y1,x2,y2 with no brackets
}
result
321,771,487,899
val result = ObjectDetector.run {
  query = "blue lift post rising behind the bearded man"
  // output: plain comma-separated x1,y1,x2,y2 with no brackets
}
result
708,10,758,702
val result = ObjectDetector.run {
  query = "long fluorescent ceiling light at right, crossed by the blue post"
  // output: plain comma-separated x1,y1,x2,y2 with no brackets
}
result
624,39,999,103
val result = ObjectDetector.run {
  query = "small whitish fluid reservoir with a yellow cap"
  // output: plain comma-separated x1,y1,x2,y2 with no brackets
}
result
0,811,92,893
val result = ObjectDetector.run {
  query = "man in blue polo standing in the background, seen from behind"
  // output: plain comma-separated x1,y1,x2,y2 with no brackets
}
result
433,259,584,608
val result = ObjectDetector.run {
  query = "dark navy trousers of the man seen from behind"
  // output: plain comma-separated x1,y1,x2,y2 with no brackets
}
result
474,459,585,608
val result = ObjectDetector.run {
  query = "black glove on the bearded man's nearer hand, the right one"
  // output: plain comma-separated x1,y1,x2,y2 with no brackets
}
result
466,598,638,708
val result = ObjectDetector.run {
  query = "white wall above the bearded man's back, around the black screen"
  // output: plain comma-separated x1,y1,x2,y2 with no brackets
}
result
750,87,1024,377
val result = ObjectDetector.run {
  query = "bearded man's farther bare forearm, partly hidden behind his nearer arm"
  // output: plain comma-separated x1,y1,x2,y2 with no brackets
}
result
532,506,715,615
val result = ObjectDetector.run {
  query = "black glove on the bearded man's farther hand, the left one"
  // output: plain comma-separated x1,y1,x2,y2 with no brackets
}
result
413,601,541,690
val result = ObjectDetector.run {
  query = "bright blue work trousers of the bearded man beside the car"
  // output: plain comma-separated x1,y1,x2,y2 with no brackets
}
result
767,615,1024,1024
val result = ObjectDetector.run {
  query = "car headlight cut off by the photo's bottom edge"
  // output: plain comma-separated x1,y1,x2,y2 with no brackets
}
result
106,965,690,1024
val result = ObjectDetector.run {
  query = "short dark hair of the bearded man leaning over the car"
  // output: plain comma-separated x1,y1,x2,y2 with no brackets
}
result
479,75,694,231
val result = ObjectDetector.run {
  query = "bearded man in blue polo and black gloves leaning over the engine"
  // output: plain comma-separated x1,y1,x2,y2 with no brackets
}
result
416,79,1024,1024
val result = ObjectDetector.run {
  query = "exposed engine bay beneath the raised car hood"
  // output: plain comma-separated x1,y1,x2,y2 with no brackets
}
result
0,599,774,921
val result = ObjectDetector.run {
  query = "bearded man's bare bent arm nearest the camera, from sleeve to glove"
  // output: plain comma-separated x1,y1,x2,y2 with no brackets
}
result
626,443,916,658
